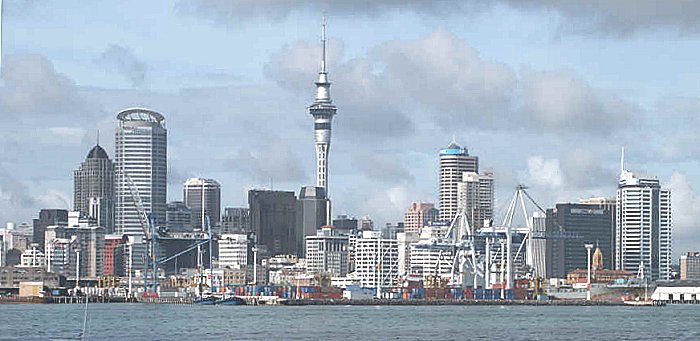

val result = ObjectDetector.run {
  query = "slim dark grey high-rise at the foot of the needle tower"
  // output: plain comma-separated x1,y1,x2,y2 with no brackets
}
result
296,186,330,257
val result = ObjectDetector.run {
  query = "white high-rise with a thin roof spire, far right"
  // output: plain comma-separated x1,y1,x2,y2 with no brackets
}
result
615,168,673,280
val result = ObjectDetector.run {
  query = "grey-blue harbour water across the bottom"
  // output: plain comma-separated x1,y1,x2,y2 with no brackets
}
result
0,304,700,341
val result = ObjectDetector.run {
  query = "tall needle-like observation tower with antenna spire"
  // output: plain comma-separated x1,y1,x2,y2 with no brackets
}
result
309,17,336,196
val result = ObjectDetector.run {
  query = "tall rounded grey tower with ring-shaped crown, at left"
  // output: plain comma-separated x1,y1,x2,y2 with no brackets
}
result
114,108,168,269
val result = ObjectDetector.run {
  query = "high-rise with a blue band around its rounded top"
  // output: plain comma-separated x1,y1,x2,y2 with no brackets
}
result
440,141,479,221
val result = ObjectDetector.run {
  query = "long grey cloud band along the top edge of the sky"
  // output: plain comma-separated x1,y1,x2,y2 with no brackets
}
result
183,0,700,37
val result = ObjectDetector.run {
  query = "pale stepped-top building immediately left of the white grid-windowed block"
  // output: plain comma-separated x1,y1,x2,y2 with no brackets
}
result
306,226,349,277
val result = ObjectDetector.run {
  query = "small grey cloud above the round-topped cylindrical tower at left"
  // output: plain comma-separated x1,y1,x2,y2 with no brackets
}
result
95,44,146,87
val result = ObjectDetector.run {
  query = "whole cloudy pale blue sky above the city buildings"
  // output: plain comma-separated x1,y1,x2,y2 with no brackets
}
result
0,0,700,258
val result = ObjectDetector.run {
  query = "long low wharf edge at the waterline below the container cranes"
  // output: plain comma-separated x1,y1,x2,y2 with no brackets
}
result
280,299,625,306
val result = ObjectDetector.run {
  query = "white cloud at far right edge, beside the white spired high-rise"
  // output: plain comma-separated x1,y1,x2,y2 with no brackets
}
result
666,172,700,258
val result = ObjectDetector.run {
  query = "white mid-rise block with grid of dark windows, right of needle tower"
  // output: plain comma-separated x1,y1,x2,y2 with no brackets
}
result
355,231,399,288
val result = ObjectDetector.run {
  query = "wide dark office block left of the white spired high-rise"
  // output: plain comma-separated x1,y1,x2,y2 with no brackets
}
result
545,203,614,278
